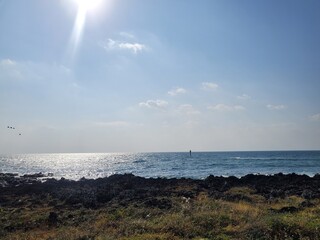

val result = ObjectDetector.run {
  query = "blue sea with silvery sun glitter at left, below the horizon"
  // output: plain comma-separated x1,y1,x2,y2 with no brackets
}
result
0,151,320,180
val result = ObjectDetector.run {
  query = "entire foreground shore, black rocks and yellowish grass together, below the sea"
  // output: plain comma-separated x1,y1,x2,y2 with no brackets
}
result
0,173,320,240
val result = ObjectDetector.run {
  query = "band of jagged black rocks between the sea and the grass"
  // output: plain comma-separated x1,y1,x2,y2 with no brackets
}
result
0,173,320,209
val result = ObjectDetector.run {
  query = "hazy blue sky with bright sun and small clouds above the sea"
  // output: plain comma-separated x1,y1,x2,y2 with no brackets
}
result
0,0,320,153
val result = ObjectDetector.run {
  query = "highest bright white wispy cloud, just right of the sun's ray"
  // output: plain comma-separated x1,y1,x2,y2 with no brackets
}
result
101,38,147,54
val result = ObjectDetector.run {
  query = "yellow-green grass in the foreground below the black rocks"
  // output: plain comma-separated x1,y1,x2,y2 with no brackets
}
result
0,187,320,240
